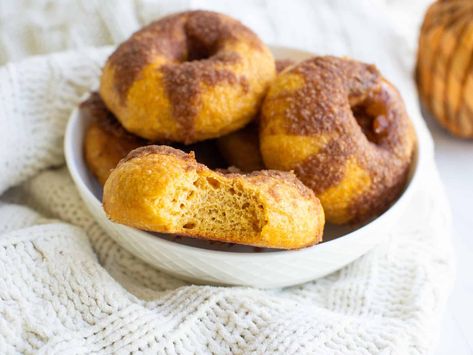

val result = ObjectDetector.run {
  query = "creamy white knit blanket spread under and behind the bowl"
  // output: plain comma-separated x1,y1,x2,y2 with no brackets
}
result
0,0,453,354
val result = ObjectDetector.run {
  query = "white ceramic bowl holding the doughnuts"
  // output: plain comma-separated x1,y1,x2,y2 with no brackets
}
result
64,47,423,288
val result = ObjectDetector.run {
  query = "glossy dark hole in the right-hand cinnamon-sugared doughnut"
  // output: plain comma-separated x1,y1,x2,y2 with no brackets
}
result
351,103,388,144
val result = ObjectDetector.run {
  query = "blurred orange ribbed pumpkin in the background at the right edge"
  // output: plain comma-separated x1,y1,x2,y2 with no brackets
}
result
416,0,473,138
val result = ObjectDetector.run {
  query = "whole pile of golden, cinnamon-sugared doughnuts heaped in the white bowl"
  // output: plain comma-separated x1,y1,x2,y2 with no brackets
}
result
81,11,415,249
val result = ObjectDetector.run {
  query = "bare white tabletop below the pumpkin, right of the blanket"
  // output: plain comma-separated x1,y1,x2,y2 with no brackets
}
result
426,117,473,355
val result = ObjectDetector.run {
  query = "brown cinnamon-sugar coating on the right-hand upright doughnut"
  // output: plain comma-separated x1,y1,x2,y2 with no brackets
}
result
264,57,415,222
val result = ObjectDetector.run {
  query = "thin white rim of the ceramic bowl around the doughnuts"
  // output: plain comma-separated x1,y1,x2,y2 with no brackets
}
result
63,45,428,258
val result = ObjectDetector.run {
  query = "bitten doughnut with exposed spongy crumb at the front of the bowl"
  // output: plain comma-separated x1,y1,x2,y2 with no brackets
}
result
103,146,324,249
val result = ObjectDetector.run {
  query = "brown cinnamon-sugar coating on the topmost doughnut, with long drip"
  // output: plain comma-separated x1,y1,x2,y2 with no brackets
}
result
104,11,264,143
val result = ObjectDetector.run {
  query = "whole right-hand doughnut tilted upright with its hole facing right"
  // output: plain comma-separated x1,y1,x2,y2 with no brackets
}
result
260,57,415,224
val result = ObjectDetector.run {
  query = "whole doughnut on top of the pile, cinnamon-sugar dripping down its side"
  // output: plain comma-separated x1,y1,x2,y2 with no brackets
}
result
100,11,275,144
